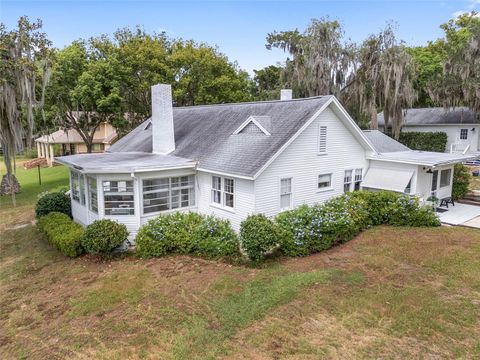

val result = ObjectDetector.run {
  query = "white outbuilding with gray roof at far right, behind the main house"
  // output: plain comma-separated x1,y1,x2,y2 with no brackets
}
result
378,107,480,154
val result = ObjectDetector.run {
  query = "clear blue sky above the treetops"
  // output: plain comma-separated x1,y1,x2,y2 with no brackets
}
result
0,0,480,73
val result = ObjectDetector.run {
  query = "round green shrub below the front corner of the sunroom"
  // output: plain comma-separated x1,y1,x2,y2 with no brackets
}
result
81,219,128,256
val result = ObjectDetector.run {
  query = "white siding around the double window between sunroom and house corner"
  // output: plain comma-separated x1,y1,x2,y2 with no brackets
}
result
197,171,255,231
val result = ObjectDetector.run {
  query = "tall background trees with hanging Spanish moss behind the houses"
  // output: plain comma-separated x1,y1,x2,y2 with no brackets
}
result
0,12,480,194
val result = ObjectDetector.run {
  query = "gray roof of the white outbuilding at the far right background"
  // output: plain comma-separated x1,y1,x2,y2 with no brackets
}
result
378,107,480,126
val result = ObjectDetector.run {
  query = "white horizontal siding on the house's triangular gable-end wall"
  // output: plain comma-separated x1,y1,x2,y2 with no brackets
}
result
255,107,368,216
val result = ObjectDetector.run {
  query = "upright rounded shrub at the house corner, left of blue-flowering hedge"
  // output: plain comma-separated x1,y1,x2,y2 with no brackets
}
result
240,214,281,261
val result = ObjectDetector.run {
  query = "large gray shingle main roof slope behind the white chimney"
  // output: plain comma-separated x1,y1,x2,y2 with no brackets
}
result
108,96,331,176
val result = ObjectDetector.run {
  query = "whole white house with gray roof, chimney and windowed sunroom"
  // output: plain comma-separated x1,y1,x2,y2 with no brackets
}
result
56,85,476,239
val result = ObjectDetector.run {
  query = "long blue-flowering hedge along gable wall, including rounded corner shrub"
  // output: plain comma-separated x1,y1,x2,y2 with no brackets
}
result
240,191,440,261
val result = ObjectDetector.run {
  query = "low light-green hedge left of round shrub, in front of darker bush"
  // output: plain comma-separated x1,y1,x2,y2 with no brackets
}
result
38,212,84,257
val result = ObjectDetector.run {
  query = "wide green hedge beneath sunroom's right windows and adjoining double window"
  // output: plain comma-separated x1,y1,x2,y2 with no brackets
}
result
135,212,240,258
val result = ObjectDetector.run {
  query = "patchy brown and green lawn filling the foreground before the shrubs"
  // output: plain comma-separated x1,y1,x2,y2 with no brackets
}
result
0,226,480,359
